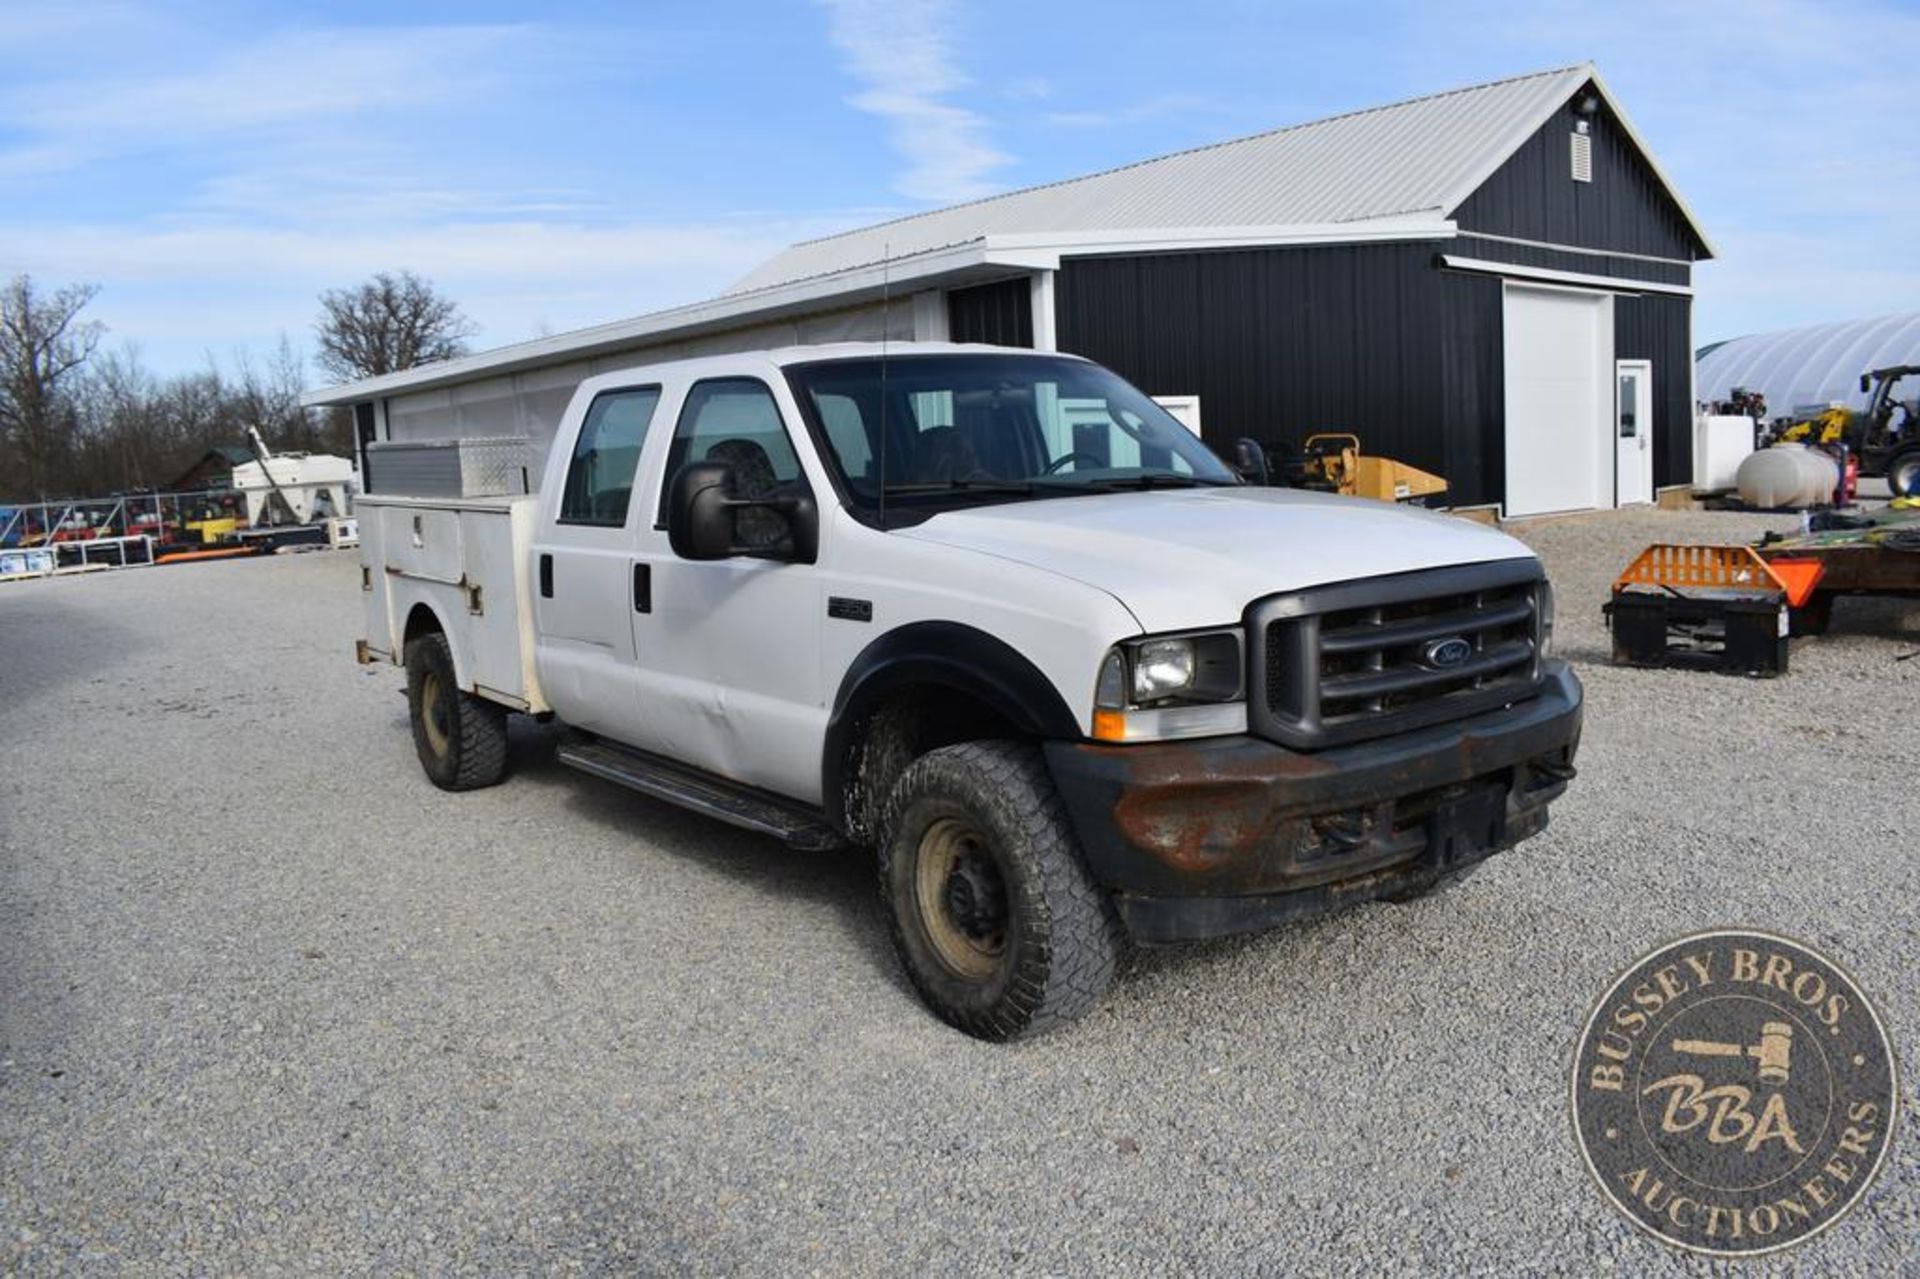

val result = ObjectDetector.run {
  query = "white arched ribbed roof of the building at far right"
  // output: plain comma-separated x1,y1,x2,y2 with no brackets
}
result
1693,311,1920,415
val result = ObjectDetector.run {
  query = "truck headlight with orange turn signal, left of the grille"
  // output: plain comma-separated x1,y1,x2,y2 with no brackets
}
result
1094,628,1246,741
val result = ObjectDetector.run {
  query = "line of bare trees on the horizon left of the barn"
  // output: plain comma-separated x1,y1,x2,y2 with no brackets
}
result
0,271,474,501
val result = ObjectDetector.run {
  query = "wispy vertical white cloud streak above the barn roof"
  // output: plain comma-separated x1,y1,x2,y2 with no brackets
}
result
820,0,1008,202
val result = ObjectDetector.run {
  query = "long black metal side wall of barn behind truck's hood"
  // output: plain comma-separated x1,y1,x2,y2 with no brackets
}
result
1054,242,1505,505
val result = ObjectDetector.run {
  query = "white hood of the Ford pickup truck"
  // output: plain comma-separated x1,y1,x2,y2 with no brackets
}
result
897,486,1532,632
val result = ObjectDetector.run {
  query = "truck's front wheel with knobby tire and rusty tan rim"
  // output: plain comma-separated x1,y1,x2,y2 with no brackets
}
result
879,741,1121,1039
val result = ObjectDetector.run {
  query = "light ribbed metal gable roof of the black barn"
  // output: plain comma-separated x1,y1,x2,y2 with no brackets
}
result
733,63,1705,292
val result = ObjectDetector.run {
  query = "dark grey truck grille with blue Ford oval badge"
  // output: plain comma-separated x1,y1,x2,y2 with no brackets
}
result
1246,559,1546,749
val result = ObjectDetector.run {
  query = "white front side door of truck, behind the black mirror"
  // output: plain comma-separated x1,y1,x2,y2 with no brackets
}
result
634,376,826,801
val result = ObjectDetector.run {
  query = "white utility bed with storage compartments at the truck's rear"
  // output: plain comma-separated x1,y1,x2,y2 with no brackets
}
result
357,494,547,714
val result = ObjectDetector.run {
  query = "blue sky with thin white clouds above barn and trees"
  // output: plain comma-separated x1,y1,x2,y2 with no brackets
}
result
0,0,1920,373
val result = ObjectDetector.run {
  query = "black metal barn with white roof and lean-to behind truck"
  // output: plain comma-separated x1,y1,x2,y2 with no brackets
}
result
309,63,1713,515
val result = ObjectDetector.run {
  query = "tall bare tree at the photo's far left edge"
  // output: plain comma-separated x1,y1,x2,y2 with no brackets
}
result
0,275,106,497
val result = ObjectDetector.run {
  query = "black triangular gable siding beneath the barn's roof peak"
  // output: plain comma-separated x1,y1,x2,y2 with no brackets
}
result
1453,94,1707,261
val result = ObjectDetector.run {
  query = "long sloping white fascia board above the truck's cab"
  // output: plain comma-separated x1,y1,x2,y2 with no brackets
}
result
300,240,995,407
